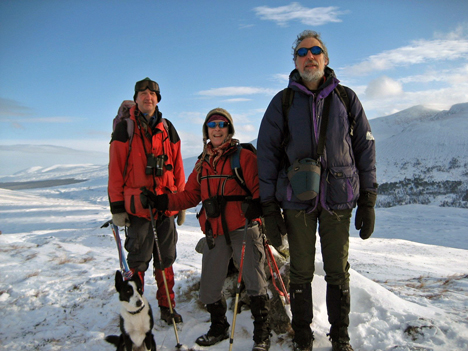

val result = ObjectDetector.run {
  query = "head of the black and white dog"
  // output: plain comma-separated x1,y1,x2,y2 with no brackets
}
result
115,271,145,313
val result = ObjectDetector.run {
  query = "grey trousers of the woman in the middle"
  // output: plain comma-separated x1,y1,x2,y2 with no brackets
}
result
200,225,267,305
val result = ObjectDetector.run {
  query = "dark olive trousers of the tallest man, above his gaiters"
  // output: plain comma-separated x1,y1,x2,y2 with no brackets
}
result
284,206,352,285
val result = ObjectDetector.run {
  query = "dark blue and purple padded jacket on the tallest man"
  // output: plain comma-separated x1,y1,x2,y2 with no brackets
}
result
257,67,377,212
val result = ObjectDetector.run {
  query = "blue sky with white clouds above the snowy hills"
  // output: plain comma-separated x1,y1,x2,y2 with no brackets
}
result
0,0,468,157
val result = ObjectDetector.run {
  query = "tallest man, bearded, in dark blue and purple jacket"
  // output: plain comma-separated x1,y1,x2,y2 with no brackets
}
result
257,31,377,351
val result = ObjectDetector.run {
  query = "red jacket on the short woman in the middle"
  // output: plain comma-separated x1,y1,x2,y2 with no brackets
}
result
168,142,259,237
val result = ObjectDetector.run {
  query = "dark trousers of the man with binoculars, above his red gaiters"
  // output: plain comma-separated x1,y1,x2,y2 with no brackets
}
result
125,215,178,272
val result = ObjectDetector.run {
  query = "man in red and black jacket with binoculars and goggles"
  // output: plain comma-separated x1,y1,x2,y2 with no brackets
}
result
108,78,185,324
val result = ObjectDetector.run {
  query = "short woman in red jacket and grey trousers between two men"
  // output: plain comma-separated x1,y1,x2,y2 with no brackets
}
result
142,108,270,351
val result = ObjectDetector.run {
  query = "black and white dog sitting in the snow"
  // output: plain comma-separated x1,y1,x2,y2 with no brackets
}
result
106,271,156,351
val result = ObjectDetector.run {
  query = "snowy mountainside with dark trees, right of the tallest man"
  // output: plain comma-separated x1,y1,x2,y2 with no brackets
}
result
370,103,468,208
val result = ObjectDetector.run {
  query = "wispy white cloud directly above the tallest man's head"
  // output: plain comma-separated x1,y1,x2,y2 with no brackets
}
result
254,2,346,27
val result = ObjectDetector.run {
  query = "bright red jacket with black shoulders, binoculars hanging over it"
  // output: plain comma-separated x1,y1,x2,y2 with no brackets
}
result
108,106,185,219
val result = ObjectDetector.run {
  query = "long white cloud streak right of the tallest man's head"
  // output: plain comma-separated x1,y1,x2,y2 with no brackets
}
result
344,39,468,76
